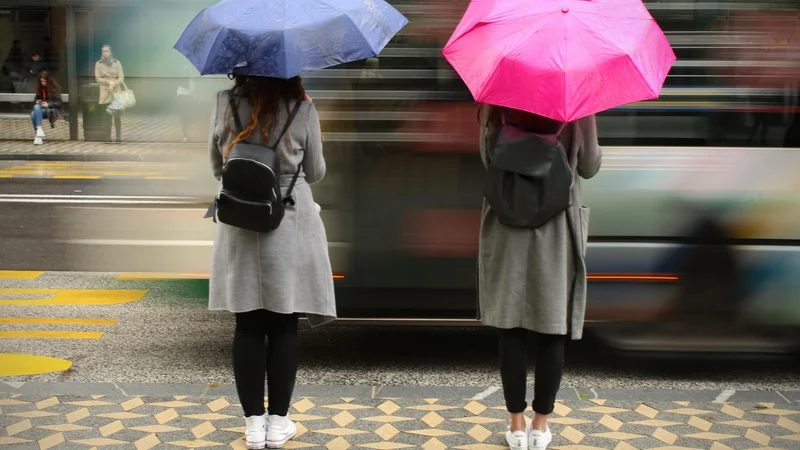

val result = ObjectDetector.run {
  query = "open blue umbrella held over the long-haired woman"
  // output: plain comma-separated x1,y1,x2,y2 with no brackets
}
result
175,0,408,78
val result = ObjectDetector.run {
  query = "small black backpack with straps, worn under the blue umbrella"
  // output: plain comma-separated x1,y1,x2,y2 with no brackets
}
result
216,92,303,233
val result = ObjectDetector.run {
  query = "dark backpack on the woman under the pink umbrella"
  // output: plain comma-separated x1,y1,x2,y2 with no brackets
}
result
483,125,572,228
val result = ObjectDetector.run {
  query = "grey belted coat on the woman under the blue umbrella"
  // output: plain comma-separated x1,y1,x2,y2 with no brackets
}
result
208,91,336,325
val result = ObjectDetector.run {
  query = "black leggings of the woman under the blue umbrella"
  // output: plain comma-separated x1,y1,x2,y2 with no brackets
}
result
233,309,300,417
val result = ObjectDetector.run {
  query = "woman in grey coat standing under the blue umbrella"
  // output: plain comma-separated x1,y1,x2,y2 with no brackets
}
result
209,76,336,448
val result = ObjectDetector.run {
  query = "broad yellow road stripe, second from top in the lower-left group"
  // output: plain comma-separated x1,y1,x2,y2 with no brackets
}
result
0,289,147,306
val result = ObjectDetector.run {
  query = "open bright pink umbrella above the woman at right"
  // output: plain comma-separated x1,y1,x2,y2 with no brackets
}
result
442,0,675,122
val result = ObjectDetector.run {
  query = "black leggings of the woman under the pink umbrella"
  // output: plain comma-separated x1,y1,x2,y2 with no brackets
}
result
500,328,567,414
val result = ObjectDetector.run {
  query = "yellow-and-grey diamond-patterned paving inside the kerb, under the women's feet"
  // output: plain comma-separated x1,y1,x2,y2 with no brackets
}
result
0,395,800,450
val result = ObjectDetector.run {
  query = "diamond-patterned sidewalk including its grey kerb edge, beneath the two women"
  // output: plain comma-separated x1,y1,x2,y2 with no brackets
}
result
0,383,800,450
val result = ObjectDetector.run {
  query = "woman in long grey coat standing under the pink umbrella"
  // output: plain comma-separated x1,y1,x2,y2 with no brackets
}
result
478,105,602,450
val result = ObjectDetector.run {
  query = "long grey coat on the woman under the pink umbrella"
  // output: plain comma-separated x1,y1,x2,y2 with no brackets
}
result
478,107,602,339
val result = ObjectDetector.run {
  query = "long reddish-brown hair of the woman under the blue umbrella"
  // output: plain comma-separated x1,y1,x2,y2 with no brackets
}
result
225,75,306,158
